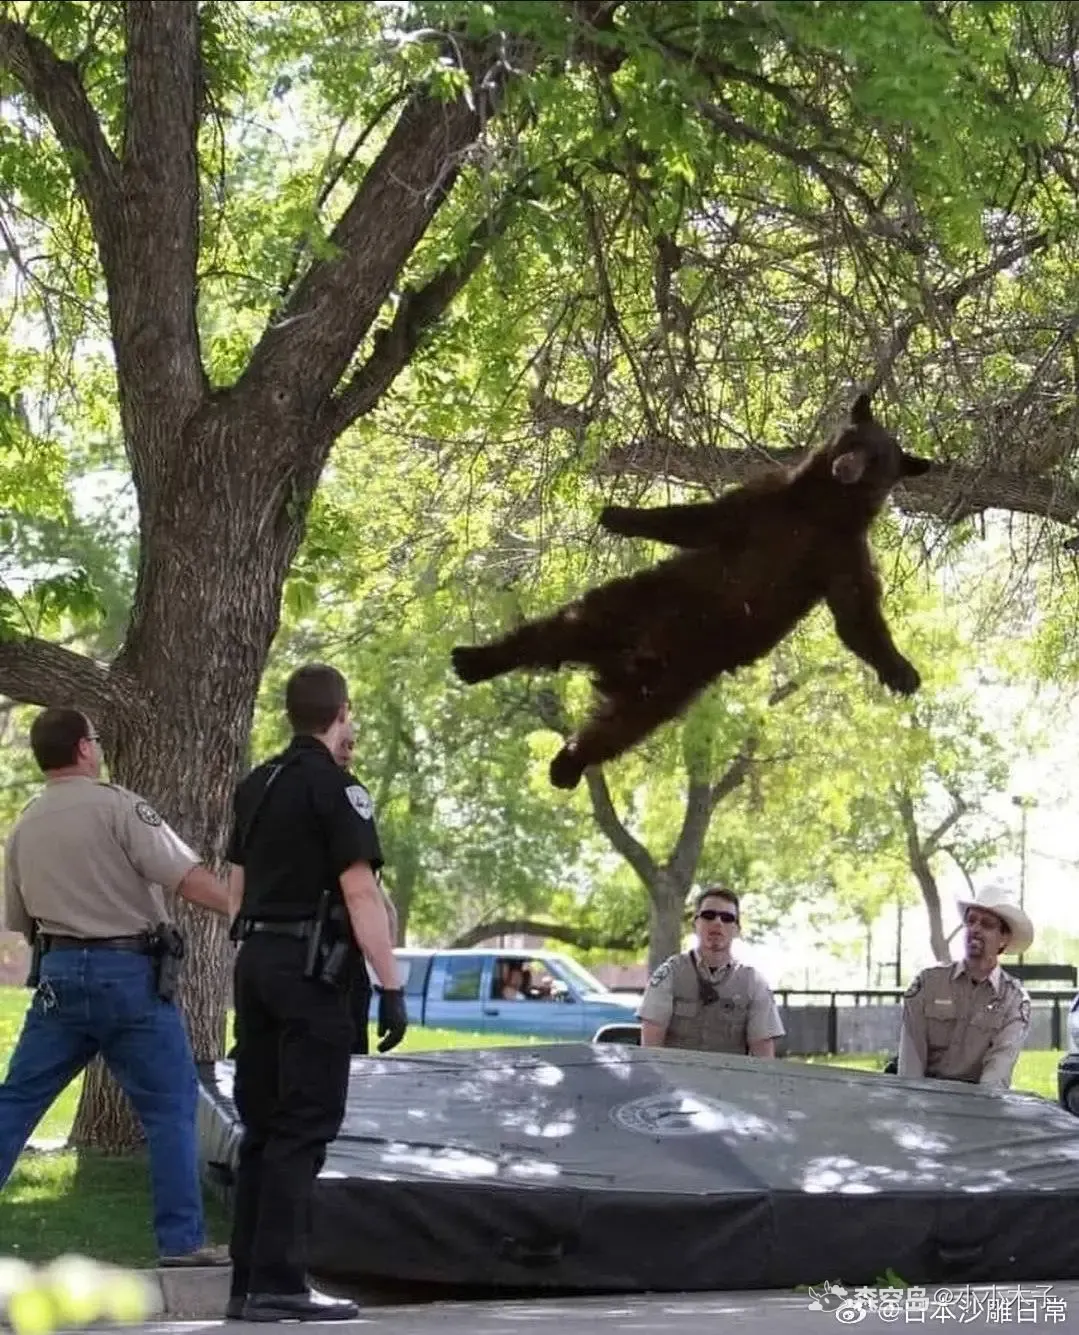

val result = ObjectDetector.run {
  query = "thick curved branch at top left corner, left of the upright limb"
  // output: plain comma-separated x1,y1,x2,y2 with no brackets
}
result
0,19,120,244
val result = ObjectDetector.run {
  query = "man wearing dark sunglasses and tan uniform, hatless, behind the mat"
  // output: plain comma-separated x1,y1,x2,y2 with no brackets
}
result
637,885,787,1057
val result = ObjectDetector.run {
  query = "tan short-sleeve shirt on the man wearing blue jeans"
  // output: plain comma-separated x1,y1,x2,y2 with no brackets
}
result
4,777,202,937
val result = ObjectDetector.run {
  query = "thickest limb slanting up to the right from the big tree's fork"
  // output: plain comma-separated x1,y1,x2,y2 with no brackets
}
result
244,41,527,413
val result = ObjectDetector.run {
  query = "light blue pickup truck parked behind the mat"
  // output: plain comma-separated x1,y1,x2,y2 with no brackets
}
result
394,948,638,1041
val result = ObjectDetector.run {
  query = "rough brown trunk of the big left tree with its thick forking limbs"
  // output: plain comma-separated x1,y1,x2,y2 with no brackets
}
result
0,0,560,1148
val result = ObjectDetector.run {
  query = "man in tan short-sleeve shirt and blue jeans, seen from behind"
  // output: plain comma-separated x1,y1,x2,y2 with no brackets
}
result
0,709,228,1264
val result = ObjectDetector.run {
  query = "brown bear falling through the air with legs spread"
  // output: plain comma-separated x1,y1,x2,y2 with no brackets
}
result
453,394,932,788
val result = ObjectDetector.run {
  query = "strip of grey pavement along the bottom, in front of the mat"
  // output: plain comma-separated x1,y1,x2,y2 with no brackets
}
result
140,1283,1079,1335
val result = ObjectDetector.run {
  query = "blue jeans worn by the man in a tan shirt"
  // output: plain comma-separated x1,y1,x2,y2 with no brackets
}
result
0,951,204,1256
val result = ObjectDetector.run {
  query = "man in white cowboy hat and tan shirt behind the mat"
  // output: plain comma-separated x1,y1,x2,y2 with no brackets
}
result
899,885,1034,1089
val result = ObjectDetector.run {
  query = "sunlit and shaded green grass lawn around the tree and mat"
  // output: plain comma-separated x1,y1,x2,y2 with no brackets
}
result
0,987,1062,1266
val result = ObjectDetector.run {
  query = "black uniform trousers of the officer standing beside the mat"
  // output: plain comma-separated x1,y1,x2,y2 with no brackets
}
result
230,933,353,1296
